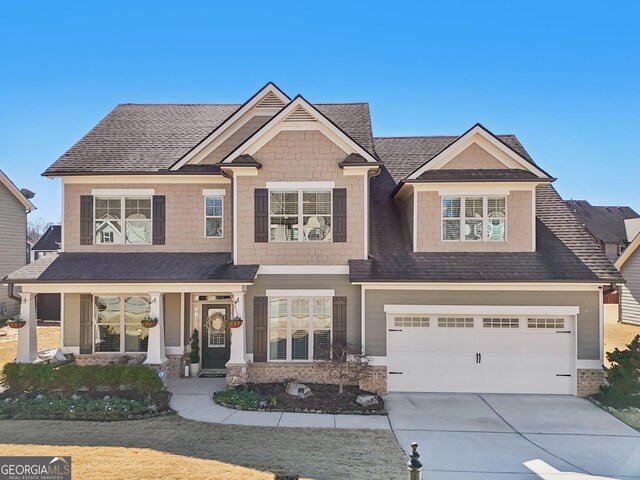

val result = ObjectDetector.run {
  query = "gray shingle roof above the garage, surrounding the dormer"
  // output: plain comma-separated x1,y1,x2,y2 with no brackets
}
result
349,141,623,282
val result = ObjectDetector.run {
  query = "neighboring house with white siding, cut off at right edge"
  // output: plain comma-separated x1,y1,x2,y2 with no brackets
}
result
615,232,640,325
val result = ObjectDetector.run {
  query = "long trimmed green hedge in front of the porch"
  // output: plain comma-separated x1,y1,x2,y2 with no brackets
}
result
1,363,164,396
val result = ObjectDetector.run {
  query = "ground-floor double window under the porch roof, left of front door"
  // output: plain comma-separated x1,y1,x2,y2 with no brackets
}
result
93,296,149,353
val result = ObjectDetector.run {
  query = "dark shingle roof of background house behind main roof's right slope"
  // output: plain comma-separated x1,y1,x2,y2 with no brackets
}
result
567,200,640,244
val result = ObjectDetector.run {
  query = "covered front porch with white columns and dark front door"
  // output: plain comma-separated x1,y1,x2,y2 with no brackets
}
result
10,283,249,376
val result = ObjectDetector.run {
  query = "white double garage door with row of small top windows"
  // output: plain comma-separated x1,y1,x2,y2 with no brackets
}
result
387,314,575,394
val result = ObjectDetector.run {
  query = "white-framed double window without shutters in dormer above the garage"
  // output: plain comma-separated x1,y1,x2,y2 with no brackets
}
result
442,196,507,242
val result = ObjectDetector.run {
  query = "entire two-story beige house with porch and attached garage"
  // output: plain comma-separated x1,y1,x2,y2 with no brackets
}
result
5,84,623,395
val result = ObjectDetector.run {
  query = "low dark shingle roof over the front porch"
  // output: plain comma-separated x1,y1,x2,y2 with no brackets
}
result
6,252,258,283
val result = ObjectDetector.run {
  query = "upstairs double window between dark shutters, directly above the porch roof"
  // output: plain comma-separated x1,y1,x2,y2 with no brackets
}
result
93,197,152,245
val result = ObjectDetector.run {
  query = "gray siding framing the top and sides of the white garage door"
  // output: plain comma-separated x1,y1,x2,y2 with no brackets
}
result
365,290,600,360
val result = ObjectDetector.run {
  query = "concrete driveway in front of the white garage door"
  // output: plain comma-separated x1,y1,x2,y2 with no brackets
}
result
385,393,640,480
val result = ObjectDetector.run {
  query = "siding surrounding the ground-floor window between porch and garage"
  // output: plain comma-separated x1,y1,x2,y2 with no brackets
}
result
245,275,360,353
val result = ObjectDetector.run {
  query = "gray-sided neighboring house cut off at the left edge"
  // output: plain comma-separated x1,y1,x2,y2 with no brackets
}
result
0,170,35,320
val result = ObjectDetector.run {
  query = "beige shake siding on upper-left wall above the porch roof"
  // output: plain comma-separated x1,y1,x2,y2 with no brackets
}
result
63,182,232,252
